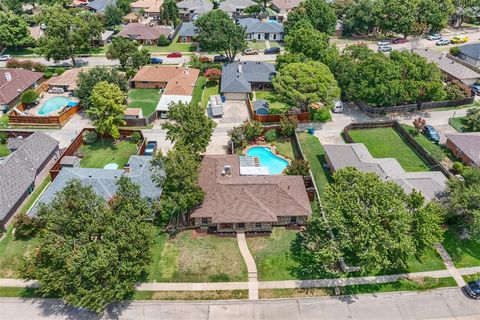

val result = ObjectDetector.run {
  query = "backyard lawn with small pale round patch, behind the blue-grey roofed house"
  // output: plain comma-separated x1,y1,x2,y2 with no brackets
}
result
80,139,137,168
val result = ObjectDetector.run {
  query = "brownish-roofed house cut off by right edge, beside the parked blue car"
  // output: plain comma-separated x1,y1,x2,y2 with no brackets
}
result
446,132,480,167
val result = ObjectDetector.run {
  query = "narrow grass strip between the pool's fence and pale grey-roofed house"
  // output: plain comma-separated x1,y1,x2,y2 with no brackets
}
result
298,132,332,197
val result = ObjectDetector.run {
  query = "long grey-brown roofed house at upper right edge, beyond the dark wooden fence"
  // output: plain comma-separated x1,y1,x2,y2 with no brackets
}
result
415,49,480,86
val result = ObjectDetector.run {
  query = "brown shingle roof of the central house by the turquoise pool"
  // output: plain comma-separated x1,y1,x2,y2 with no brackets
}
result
191,155,312,223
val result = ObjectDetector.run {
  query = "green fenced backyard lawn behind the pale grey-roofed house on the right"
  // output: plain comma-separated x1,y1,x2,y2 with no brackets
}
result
344,128,430,172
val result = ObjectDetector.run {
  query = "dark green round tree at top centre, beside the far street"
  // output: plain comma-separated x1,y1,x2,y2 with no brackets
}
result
195,10,247,61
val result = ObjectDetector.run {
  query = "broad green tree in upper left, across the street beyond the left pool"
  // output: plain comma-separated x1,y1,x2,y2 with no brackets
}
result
38,5,103,67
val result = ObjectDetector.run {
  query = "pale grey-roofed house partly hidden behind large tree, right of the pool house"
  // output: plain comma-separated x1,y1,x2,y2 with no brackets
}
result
324,143,447,200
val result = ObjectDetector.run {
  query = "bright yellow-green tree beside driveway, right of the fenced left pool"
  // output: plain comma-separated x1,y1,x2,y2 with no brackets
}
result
87,81,127,139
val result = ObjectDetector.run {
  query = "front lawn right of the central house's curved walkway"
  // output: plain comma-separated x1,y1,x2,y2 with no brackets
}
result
247,228,297,281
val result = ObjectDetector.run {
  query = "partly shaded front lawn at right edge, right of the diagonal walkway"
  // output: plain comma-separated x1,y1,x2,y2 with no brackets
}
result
443,227,480,268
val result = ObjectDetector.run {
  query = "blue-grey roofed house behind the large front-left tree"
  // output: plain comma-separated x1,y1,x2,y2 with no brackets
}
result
28,156,164,216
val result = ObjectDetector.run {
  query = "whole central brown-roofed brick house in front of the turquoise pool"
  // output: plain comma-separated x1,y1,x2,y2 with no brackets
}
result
190,155,312,233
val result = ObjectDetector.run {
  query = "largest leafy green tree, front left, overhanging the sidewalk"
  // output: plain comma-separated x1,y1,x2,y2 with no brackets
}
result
23,176,153,312
